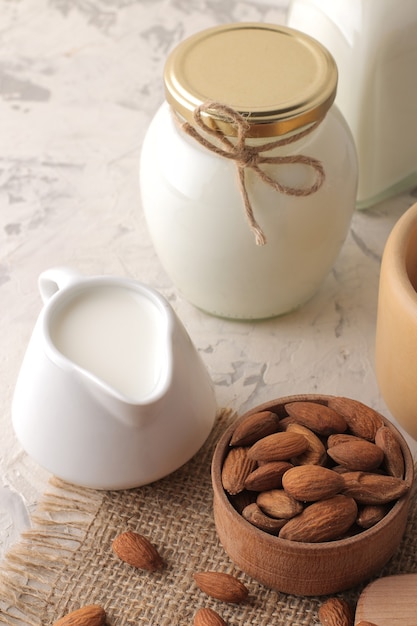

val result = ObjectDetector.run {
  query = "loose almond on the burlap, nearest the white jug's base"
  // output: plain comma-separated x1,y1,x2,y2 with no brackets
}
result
112,530,163,572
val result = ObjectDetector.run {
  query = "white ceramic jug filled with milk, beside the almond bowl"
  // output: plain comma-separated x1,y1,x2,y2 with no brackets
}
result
12,268,216,489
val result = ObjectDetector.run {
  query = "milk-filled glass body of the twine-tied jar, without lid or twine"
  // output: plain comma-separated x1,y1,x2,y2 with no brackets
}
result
140,103,357,319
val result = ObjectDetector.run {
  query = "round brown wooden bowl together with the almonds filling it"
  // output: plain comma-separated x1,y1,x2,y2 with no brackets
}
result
212,394,414,596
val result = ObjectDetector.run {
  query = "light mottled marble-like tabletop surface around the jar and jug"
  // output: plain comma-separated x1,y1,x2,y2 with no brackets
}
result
0,0,416,553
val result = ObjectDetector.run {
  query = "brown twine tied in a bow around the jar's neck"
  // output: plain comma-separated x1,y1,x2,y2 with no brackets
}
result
176,101,325,245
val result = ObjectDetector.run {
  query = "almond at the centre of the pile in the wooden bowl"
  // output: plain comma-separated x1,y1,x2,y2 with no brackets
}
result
282,465,344,502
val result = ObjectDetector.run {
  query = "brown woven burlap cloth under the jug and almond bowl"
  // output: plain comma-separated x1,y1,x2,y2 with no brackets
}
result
0,410,417,626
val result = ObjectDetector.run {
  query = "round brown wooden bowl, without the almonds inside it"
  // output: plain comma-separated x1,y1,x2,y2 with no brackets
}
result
212,394,414,596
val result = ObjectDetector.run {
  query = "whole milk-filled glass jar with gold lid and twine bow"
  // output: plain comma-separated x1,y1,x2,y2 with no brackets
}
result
140,23,357,319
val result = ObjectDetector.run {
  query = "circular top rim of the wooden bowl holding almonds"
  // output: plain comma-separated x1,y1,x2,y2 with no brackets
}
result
211,394,414,553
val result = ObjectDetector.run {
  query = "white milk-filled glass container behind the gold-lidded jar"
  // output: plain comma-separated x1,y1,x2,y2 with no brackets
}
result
287,0,417,208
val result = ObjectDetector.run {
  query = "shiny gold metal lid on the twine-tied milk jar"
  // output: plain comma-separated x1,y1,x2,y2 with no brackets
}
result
164,22,337,137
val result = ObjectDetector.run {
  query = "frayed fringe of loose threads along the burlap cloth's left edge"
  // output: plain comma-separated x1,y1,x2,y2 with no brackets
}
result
0,477,104,626
